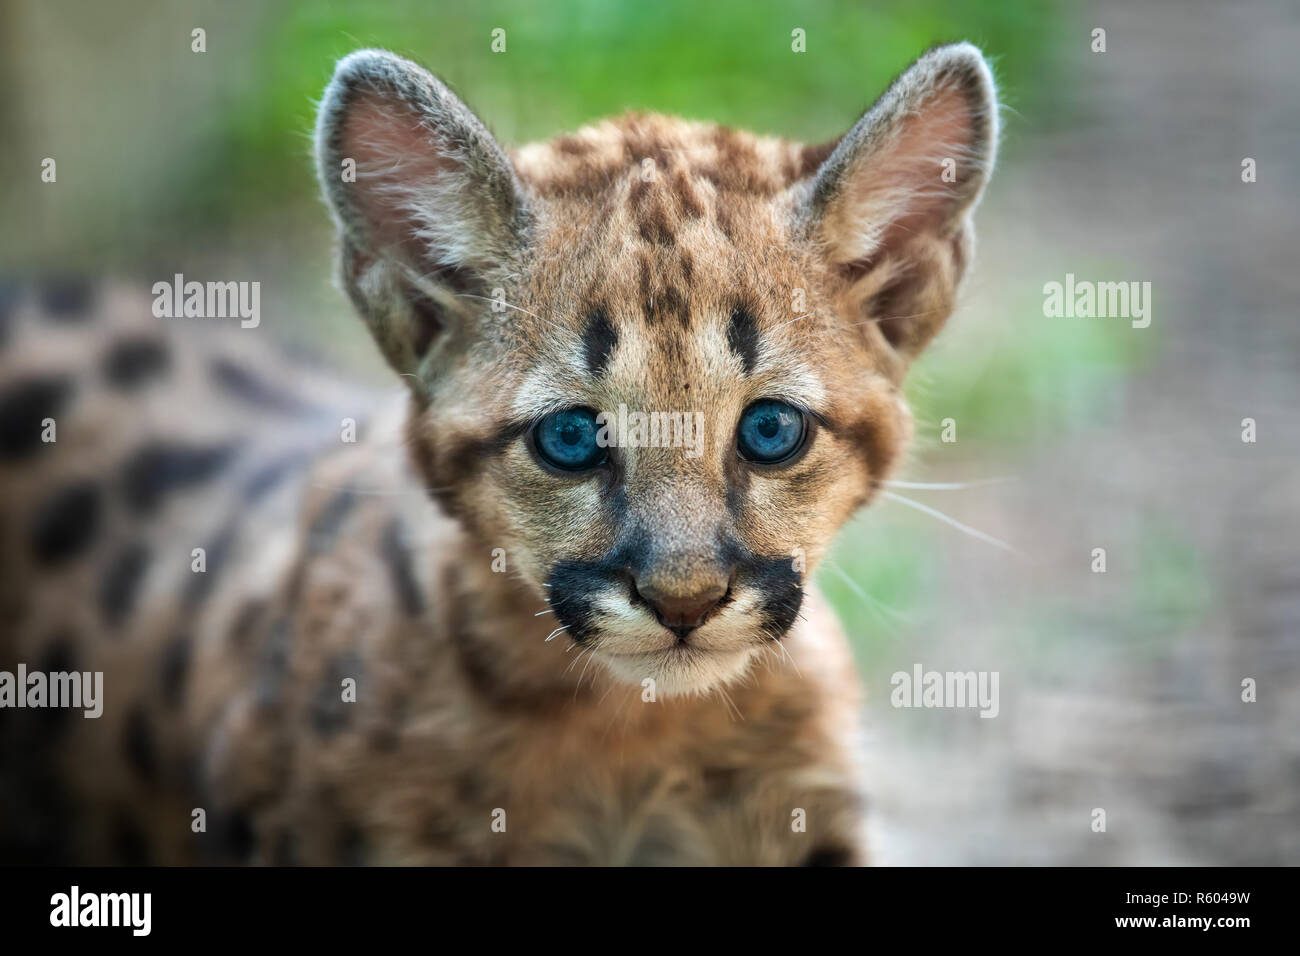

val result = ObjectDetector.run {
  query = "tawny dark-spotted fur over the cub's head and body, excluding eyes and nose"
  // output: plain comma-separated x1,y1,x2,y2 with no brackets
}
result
0,44,996,865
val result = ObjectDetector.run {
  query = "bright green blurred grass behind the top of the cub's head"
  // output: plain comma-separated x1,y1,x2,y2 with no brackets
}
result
157,0,1060,247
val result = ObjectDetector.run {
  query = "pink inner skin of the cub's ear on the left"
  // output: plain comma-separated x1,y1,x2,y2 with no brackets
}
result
339,92,462,260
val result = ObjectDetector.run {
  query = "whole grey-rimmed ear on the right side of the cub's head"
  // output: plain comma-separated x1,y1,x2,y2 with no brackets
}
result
797,43,997,369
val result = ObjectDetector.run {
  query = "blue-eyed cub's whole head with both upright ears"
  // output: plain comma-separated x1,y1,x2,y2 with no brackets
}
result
316,44,997,693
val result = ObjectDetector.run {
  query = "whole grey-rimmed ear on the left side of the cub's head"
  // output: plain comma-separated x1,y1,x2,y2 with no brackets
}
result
316,49,529,388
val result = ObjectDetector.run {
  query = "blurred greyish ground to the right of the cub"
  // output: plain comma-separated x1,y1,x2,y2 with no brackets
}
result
855,0,1300,865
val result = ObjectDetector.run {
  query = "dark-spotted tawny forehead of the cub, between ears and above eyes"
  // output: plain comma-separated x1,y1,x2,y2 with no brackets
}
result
501,116,824,418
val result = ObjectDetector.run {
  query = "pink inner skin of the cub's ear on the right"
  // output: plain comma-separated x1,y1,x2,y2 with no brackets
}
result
823,81,980,264
